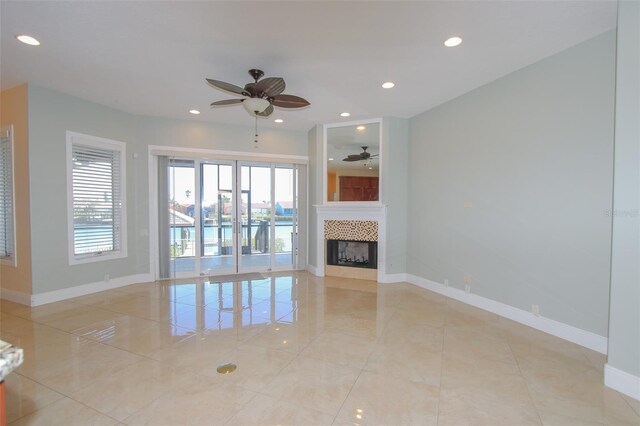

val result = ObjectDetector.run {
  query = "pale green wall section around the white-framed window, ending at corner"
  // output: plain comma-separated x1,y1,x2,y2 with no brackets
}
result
28,85,139,294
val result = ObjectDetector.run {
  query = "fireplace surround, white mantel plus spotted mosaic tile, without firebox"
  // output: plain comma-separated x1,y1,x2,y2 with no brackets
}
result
314,203,386,281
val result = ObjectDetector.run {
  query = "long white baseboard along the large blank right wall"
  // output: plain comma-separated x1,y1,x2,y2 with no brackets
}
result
407,274,607,354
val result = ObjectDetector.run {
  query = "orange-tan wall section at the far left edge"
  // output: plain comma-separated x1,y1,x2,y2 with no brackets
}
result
0,84,31,296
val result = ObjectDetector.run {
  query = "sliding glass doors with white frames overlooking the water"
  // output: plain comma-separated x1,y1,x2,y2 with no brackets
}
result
158,157,299,278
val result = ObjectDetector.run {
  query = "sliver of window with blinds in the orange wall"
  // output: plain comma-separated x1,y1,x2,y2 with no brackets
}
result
0,127,15,265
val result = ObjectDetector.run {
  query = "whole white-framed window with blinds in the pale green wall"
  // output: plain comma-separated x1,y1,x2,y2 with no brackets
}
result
67,133,126,264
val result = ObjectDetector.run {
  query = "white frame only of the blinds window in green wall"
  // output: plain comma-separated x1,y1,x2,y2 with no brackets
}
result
66,131,127,265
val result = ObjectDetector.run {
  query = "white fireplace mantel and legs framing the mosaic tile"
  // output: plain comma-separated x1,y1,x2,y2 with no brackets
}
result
313,202,387,277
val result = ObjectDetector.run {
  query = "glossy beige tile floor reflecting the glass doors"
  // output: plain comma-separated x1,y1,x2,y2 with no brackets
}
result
0,273,640,426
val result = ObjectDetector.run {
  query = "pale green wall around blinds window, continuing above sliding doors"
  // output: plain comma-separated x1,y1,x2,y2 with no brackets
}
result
29,86,307,294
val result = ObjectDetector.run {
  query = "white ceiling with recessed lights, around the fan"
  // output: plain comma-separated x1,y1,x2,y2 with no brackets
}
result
0,0,616,130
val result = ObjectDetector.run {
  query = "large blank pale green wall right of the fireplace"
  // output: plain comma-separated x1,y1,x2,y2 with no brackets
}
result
407,31,615,336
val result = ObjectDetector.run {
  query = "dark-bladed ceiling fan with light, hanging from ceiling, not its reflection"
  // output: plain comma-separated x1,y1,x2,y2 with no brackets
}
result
207,69,310,117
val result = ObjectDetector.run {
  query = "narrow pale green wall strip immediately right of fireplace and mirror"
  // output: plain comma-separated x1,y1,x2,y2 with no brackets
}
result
381,117,409,274
